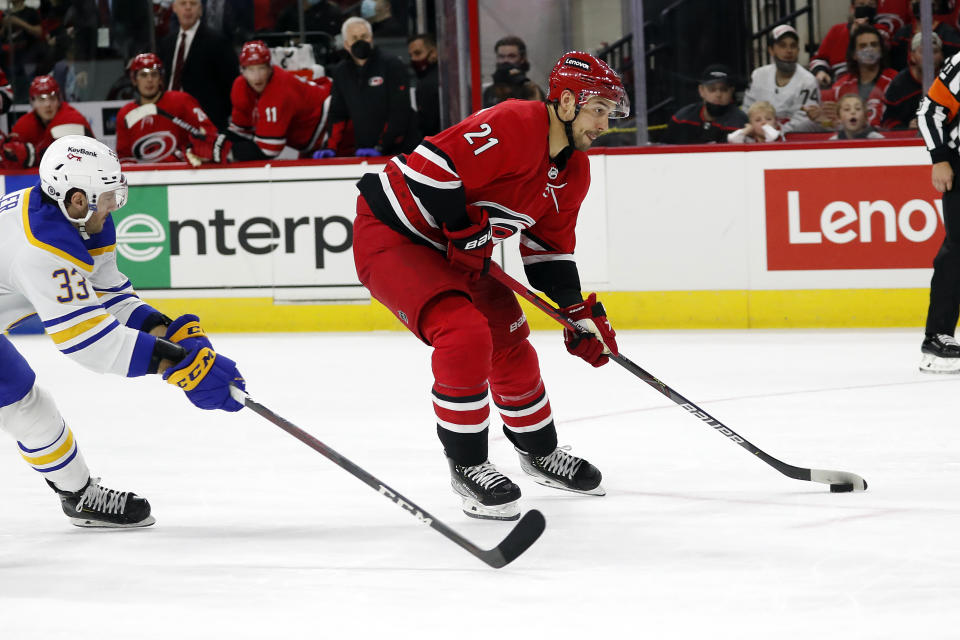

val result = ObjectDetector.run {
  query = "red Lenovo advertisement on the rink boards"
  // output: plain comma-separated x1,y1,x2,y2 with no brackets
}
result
764,165,944,271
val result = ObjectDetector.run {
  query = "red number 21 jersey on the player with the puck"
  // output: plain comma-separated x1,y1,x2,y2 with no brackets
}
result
357,100,590,278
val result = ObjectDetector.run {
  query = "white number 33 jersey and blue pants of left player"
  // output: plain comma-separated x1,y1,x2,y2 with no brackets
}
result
0,182,157,407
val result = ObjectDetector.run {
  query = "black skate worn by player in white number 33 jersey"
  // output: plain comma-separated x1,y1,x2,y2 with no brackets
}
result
47,478,156,529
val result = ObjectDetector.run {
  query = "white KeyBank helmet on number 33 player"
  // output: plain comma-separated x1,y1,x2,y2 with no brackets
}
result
40,136,127,228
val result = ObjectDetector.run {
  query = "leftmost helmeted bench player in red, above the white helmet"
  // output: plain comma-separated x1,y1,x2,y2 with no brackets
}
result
3,76,93,169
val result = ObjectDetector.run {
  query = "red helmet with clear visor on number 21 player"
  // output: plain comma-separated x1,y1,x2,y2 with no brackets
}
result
547,51,630,118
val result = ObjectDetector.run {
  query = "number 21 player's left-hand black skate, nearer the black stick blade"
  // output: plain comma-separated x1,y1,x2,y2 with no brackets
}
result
447,458,520,520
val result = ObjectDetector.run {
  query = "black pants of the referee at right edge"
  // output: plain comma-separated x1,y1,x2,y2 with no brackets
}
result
926,160,960,336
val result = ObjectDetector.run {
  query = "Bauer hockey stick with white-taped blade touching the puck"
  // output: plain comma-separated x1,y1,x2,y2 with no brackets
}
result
490,263,867,493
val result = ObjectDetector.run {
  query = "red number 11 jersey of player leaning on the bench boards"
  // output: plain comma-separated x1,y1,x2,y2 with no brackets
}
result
230,65,332,158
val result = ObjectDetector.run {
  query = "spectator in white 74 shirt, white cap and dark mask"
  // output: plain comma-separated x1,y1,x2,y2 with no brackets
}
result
743,24,821,133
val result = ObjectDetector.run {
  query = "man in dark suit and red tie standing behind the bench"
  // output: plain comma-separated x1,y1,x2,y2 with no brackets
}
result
157,0,238,129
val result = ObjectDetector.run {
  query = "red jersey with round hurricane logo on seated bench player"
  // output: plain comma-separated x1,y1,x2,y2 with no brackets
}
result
117,91,217,162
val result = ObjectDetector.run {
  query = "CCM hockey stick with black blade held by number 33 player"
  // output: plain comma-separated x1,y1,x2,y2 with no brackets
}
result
230,387,546,569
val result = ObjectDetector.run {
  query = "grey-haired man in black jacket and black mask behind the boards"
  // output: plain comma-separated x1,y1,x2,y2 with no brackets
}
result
315,17,423,158
